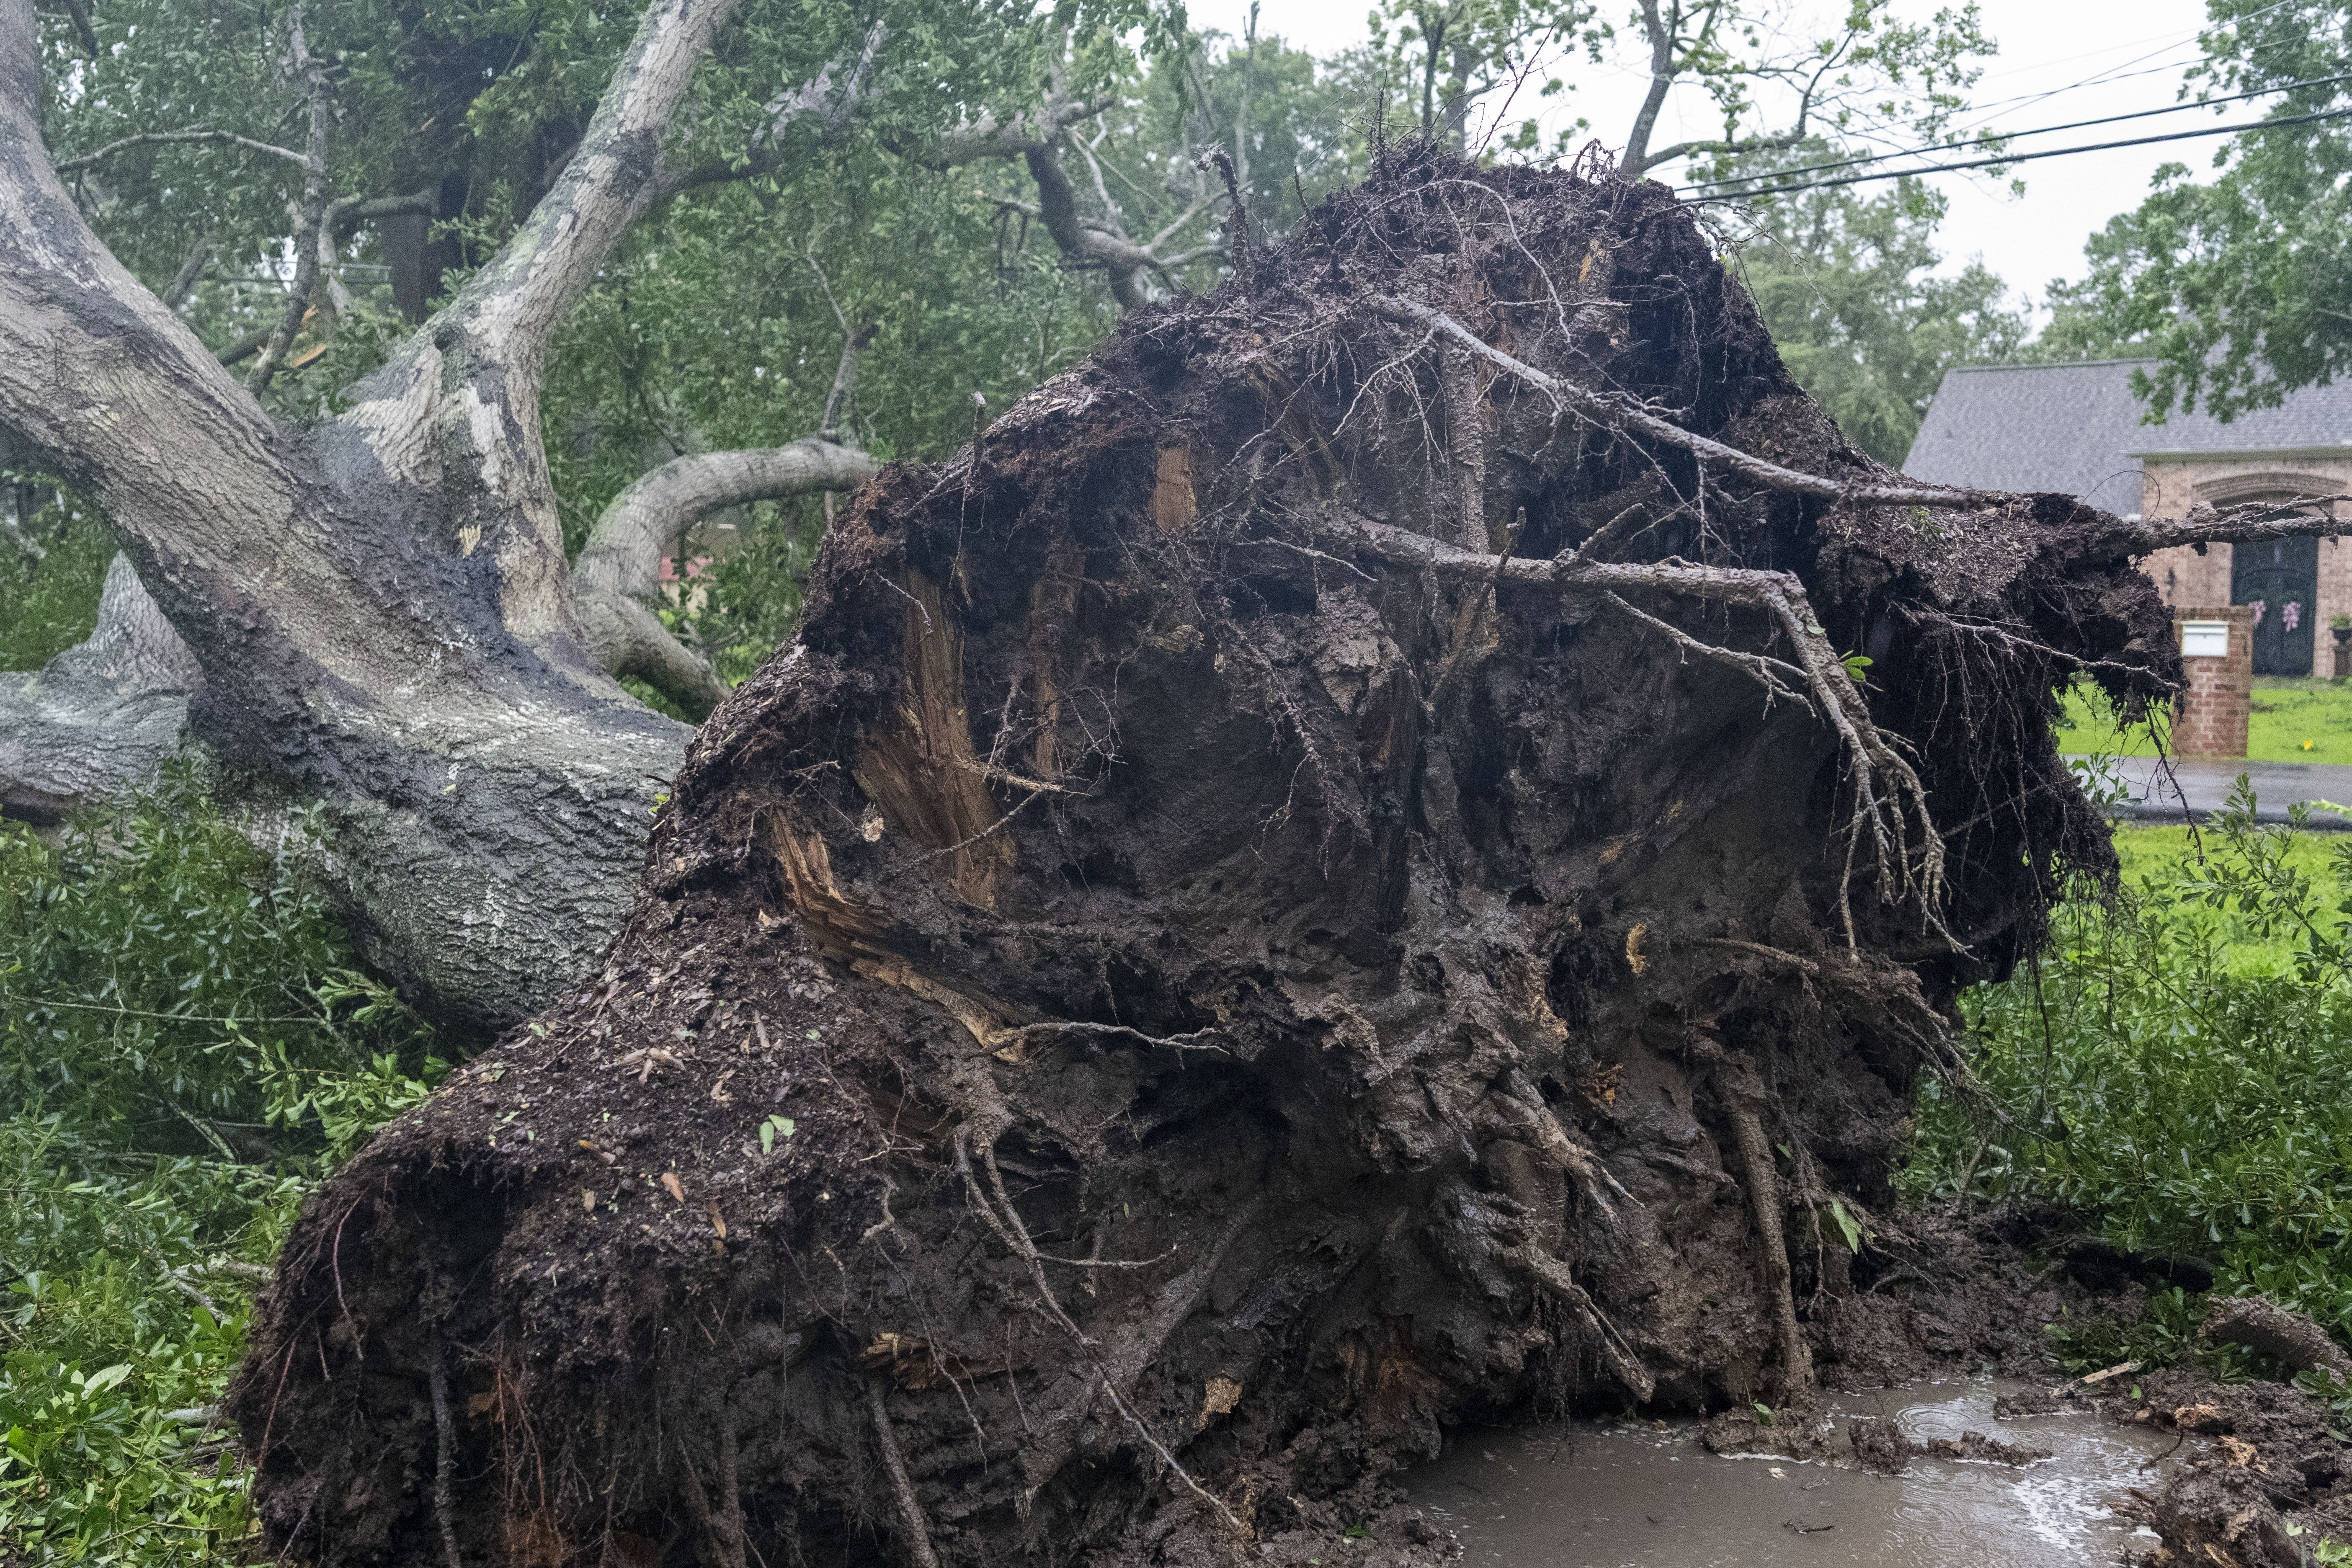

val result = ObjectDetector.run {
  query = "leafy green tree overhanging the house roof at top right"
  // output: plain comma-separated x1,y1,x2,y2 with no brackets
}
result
2051,0,2352,418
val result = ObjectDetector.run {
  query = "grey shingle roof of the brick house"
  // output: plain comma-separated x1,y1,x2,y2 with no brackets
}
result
1903,360,2352,515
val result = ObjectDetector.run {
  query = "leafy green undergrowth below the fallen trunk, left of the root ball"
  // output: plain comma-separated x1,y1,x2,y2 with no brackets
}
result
0,774,442,1563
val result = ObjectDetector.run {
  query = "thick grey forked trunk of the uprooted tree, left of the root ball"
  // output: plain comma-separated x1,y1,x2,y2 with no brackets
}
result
0,0,753,1025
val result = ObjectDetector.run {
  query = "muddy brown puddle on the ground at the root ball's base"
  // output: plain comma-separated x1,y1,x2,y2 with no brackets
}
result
1409,1380,2197,1568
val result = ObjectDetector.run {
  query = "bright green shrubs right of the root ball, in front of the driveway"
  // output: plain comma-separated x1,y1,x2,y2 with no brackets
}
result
1903,781,2352,1361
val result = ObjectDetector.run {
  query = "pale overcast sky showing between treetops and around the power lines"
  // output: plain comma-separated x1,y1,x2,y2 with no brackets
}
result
1188,0,2229,322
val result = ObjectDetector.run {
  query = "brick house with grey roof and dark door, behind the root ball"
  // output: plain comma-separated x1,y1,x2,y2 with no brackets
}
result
1903,360,2352,675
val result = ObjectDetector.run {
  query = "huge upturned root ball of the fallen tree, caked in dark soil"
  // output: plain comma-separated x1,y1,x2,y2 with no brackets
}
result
230,150,2178,1568
